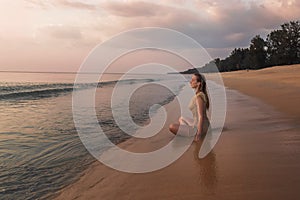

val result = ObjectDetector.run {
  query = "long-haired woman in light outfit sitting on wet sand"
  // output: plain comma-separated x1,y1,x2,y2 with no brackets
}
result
169,73,210,141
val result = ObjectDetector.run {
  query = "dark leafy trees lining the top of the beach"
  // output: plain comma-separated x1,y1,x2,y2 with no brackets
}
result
184,21,300,73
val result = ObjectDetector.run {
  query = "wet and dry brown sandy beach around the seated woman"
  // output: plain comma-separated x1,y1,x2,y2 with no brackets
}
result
56,65,300,200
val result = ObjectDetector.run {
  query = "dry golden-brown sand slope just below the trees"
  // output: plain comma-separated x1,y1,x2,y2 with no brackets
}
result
222,65,300,119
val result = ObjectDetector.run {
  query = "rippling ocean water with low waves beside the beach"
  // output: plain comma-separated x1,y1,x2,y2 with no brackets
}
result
0,72,183,199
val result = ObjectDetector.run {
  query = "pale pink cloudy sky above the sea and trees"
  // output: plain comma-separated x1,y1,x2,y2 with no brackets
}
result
0,0,300,72
